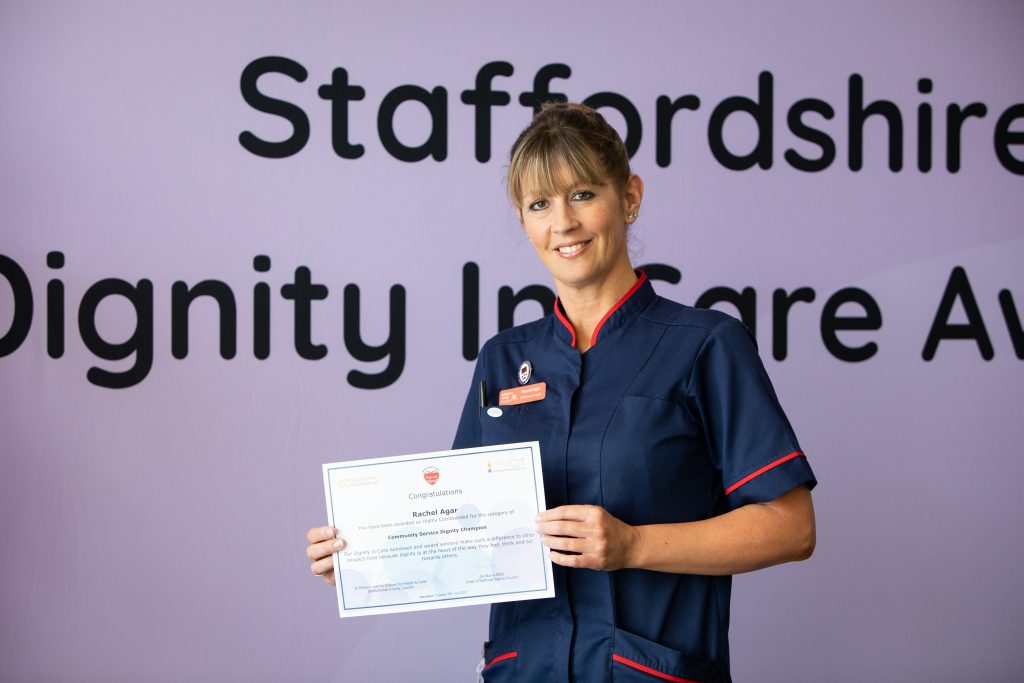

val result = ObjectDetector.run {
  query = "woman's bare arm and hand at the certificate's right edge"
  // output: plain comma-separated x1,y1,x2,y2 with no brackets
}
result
538,486,815,575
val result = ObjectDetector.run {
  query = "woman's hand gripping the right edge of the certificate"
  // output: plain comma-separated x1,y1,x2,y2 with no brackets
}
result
537,505,640,570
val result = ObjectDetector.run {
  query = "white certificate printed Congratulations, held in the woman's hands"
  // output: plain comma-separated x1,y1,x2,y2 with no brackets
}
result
324,441,555,616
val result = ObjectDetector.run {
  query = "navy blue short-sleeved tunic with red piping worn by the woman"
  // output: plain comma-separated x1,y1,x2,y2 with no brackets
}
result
454,273,815,683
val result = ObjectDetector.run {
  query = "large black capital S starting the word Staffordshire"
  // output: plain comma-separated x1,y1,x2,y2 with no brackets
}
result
239,57,309,159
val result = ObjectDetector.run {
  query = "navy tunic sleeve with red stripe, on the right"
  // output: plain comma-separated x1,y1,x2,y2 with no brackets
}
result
686,317,817,508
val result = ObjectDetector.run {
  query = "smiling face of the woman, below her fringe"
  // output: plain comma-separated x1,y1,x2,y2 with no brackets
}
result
518,169,643,288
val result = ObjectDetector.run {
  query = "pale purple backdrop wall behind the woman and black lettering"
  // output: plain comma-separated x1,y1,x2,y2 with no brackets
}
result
0,1,1024,681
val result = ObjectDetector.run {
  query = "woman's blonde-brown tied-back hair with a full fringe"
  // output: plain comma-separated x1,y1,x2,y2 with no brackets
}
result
508,102,632,206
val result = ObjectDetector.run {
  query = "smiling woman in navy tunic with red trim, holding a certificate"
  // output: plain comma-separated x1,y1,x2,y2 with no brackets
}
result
308,103,815,682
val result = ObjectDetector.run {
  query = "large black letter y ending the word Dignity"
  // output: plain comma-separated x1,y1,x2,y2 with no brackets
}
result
344,285,406,389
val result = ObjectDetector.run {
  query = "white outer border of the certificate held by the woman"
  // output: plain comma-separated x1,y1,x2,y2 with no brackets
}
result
324,441,551,616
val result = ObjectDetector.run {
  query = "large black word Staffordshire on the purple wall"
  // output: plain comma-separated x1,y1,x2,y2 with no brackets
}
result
239,56,1024,175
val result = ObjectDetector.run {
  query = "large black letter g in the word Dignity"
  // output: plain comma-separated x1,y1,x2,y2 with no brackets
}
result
78,278,153,389
